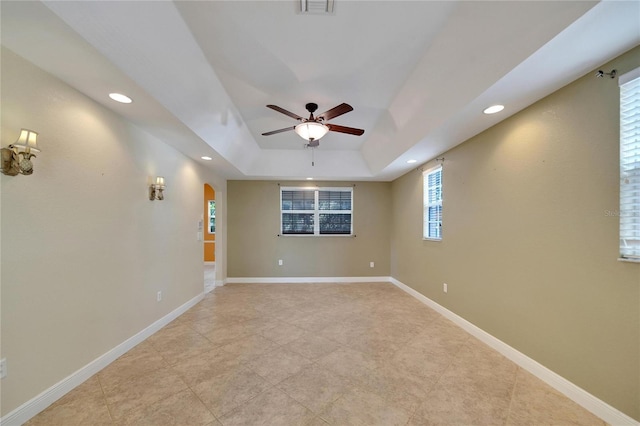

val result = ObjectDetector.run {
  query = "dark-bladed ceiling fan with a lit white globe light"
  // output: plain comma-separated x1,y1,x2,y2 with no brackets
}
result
262,103,364,148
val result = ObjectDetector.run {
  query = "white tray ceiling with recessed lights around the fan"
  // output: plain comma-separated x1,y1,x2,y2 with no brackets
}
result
0,0,640,181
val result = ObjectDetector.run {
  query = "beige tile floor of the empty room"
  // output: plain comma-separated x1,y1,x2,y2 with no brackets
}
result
27,283,604,426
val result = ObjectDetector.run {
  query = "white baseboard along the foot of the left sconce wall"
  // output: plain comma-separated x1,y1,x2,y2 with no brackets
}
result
0,293,204,426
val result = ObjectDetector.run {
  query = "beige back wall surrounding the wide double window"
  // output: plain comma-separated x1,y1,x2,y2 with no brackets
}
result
227,181,391,277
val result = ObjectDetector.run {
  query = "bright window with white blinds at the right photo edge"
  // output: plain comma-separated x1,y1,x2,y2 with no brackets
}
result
619,68,640,262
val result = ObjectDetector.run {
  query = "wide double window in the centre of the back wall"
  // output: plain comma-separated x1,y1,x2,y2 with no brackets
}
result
280,187,353,235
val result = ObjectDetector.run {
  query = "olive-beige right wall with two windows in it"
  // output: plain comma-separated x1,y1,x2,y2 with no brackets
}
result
391,47,640,420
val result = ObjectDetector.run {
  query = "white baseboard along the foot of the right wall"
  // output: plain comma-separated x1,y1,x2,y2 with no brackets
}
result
389,278,640,426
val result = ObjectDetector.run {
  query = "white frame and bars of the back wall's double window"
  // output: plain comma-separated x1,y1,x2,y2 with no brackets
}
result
278,186,355,237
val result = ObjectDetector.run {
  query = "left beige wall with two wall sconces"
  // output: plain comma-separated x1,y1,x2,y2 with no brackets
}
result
0,49,226,415
